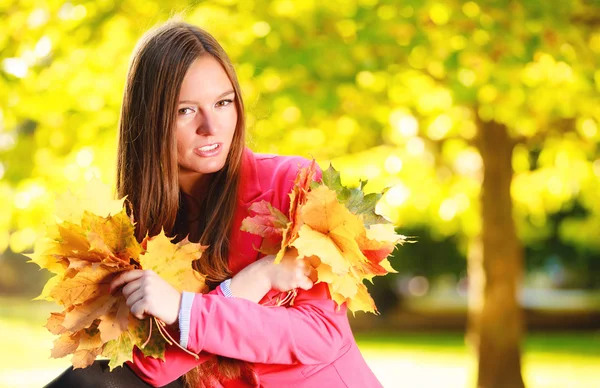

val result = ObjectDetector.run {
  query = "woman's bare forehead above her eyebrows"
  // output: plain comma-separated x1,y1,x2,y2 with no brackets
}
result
179,55,233,101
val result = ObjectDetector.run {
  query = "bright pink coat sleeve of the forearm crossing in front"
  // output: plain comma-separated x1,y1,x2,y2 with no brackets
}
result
188,283,350,365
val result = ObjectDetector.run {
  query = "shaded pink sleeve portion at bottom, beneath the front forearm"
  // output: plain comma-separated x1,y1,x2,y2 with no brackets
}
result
127,287,223,387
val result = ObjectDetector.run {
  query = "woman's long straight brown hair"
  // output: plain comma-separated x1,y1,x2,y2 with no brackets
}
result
117,20,249,386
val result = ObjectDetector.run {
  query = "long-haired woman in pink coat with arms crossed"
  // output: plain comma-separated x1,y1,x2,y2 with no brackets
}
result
49,21,381,387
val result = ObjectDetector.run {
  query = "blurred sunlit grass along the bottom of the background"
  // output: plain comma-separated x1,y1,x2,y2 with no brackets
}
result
0,299,600,388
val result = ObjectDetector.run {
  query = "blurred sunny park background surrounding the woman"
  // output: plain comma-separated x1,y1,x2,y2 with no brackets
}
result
0,0,600,388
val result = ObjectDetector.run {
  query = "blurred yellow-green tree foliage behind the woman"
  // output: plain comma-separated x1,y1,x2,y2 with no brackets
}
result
0,0,600,292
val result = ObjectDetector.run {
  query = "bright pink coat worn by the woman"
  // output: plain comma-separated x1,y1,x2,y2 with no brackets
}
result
129,149,381,388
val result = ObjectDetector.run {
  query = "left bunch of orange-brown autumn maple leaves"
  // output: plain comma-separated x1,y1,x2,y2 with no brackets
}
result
30,182,206,370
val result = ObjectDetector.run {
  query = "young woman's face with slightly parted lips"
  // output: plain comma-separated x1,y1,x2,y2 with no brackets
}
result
176,55,237,176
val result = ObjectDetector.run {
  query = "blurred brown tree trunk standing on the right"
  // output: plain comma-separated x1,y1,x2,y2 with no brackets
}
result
466,122,525,388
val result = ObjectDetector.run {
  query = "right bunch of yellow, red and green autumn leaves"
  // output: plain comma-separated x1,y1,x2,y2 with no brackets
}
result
242,160,407,313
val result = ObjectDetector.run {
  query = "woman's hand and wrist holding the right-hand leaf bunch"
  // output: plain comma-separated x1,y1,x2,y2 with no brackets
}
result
229,249,319,303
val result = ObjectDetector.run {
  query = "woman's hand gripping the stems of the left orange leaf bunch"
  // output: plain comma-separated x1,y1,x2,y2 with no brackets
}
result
110,270,181,325
